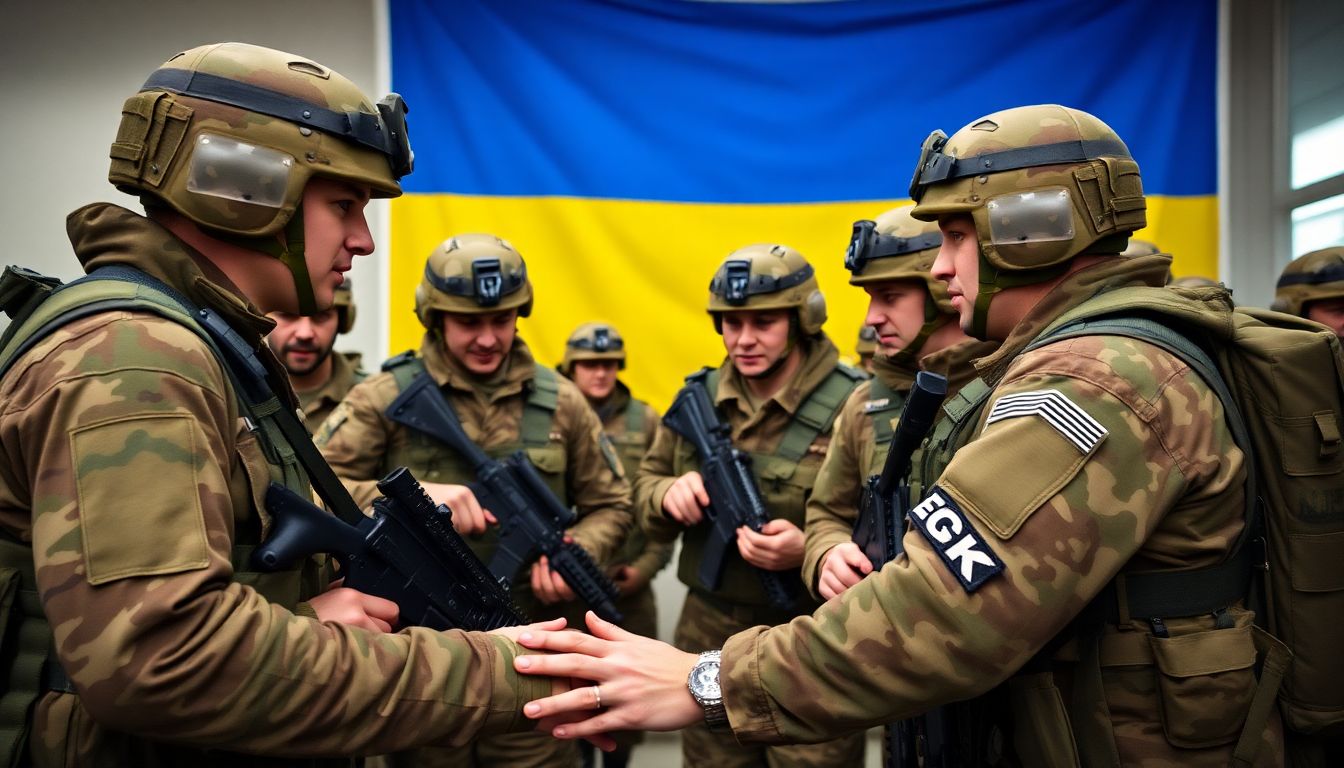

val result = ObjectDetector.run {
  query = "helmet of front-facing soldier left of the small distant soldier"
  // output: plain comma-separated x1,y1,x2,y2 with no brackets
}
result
415,233,532,325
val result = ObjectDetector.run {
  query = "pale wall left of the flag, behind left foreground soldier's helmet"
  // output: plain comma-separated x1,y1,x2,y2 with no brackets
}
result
0,0,387,364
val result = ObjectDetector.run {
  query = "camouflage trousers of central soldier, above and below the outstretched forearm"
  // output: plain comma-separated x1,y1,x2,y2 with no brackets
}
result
672,592,866,768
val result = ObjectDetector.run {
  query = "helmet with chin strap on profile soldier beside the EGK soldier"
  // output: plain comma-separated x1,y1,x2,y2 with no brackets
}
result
844,206,957,360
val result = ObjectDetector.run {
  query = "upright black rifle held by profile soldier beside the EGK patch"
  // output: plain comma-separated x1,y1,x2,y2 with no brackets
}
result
853,371,949,768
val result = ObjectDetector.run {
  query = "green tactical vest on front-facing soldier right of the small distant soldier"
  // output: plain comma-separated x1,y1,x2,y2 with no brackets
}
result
673,364,863,613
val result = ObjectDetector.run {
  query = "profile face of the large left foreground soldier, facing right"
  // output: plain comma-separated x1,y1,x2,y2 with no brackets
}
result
302,176,374,309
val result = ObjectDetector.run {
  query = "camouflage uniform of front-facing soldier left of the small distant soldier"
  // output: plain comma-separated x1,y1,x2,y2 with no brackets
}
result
317,334,630,765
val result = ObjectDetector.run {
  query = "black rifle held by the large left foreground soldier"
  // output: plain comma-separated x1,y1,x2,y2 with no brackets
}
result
251,467,527,629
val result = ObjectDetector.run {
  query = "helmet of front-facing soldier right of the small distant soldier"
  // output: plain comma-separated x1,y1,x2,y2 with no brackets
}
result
708,243,827,336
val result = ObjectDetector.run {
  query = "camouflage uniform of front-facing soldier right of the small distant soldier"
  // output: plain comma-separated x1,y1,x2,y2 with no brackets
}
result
634,335,864,767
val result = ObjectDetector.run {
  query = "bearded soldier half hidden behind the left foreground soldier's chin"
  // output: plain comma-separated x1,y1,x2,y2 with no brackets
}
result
266,277,368,429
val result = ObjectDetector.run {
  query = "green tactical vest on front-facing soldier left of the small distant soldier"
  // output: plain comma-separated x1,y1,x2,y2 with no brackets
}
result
380,352,570,562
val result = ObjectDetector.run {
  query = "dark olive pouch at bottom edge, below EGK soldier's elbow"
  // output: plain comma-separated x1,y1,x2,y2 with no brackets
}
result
1008,671,1079,768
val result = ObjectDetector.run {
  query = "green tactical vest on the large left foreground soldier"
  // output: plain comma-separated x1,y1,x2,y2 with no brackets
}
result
0,266,325,765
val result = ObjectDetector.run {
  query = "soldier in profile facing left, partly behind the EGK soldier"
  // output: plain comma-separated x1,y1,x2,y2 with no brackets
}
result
802,206,996,600
